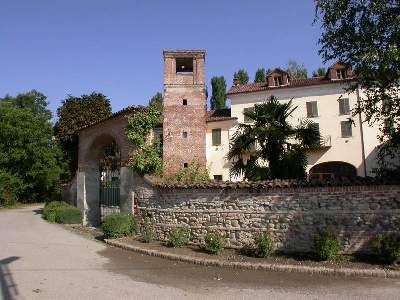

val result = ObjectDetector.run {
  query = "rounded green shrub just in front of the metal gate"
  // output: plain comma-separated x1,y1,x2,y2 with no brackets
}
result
101,213,137,238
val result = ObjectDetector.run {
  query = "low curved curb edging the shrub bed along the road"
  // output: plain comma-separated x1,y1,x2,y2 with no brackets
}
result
104,239,400,278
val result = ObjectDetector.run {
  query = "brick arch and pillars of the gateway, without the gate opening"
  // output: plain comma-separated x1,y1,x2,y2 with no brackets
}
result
77,116,135,226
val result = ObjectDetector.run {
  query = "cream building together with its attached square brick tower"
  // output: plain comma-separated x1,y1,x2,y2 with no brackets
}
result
159,50,379,181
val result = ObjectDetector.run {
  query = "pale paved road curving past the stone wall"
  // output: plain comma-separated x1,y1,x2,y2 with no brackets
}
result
0,207,400,300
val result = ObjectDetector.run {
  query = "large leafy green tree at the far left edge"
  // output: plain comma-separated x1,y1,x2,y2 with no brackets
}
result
0,91,64,205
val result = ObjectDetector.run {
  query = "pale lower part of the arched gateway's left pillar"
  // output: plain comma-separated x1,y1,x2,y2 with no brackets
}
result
77,169,100,226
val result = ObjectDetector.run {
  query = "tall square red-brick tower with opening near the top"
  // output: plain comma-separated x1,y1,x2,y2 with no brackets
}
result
163,50,207,175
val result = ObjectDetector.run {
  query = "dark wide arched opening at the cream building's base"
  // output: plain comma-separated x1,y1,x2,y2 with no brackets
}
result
309,161,357,180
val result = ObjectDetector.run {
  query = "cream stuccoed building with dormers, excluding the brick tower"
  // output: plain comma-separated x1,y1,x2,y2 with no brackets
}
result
206,63,379,180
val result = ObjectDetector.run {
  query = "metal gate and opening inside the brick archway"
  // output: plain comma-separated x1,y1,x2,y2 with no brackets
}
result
99,142,121,220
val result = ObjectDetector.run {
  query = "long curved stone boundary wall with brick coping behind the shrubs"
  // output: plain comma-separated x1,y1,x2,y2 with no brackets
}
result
134,177,400,253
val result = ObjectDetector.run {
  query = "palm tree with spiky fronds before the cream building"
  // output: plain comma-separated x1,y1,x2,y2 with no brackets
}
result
227,96,320,180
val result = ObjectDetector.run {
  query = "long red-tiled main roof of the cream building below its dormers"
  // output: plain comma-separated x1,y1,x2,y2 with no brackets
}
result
227,77,352,95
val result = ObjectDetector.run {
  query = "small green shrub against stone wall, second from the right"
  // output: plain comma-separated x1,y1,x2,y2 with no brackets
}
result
314,232,342,261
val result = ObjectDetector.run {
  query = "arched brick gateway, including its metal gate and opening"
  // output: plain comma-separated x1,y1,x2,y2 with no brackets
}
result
77,112,135,226
